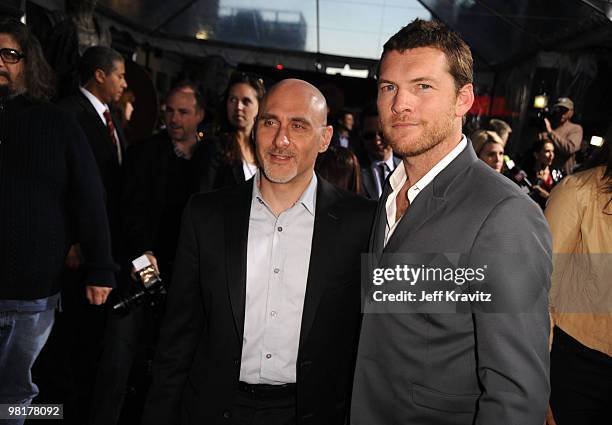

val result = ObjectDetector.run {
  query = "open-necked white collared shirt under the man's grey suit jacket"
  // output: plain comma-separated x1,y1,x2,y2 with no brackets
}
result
385,135,467,246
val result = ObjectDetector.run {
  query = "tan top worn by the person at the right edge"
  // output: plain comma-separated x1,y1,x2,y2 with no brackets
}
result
544,166,612,356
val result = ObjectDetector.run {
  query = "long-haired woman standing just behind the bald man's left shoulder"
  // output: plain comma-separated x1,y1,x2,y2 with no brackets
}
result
210,72,265,189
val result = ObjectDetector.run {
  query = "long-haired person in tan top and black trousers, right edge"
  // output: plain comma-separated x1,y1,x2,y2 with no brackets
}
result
544,127,612,425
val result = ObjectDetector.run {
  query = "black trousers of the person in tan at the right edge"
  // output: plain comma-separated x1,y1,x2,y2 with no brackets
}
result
550,327,612,425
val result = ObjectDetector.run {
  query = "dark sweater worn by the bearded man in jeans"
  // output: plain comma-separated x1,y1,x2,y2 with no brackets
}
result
0,96,115,300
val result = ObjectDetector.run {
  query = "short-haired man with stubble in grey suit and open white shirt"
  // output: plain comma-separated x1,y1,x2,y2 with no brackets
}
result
351,19,551,425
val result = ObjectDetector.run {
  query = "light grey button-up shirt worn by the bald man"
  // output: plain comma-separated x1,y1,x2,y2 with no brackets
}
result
240,171,317,385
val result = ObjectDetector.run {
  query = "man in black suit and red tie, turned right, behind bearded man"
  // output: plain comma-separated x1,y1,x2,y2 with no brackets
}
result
52,46,127,424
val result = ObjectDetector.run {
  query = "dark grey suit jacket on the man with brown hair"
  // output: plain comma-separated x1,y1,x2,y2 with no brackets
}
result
351,143,552,425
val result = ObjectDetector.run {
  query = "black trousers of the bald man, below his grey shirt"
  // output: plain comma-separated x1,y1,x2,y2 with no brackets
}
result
231,384,296,425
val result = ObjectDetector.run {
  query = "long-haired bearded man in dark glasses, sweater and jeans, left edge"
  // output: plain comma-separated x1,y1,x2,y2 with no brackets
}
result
0,20,115,424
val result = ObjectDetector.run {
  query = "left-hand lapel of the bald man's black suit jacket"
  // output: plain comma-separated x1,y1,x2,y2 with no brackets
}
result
224,180,253,344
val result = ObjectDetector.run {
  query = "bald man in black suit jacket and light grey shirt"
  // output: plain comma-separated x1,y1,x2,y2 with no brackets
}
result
143,80,375,425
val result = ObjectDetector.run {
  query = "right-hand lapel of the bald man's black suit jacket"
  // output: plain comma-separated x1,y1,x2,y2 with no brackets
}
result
300,176,340,352
